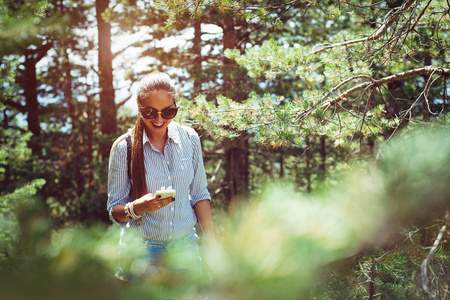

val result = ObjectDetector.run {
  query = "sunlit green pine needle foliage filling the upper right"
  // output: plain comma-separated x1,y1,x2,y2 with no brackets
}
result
168,1,449,155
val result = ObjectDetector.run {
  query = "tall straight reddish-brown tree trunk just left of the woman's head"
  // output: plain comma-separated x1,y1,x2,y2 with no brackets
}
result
95,0,117,159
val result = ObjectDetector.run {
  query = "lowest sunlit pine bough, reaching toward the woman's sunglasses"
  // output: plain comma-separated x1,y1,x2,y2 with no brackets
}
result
179,92,398,147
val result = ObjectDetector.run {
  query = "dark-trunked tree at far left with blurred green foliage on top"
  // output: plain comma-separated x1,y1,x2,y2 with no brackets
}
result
0,1,57,154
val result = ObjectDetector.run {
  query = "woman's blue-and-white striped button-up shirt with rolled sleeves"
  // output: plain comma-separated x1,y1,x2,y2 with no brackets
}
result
107,121,211,242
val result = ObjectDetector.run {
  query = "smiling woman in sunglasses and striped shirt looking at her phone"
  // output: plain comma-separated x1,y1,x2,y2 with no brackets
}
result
107,72,215,280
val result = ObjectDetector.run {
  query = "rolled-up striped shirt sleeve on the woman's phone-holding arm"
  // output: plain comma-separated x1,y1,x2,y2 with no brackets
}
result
107,139,131,227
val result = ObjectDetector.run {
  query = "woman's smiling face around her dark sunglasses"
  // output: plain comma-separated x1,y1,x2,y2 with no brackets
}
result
138,91,175,135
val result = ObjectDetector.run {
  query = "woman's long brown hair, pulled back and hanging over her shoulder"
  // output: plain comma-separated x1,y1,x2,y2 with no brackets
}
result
113,72,176,200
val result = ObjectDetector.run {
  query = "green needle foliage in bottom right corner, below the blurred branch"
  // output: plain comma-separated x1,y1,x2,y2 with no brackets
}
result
317,241,449,299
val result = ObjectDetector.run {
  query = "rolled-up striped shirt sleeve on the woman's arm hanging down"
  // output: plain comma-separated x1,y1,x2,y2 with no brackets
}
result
190,130,211,206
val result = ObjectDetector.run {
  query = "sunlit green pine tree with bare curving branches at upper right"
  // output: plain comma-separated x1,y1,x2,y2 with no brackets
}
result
163,0,449,151
